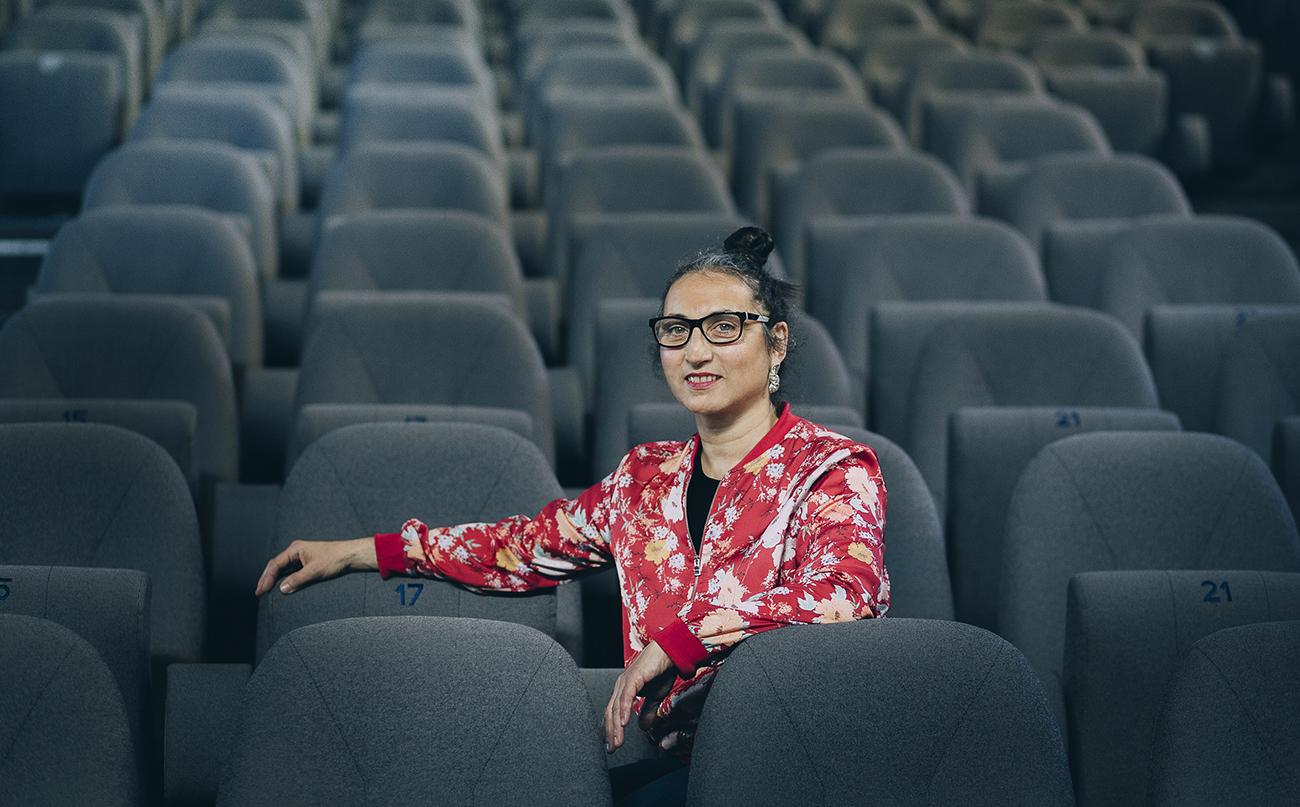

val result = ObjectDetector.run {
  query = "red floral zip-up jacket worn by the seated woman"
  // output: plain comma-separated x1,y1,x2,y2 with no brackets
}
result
374,405,889,751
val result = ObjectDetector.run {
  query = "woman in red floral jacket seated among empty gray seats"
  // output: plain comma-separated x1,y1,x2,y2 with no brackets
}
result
257,227,889,803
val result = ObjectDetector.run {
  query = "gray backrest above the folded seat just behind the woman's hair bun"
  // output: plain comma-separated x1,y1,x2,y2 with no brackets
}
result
546,146,736,286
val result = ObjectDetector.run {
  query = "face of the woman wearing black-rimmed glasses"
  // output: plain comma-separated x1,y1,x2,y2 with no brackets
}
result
659,272,788,415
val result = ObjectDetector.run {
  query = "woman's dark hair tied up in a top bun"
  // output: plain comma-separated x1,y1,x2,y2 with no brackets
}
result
659,227,798,351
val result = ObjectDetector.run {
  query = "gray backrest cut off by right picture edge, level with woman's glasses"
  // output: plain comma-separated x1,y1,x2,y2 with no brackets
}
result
1214,308,1300,459
